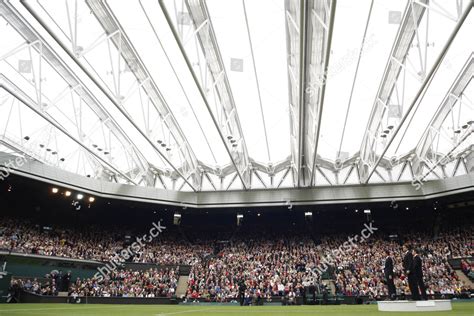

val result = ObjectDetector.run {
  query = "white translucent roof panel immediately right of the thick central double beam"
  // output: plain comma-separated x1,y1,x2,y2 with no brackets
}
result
318,0,406,160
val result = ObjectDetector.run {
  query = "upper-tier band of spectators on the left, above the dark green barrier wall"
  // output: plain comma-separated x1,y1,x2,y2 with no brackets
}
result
0,219,212,265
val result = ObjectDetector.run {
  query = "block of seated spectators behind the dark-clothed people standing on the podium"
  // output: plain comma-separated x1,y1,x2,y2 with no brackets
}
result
321,235,467,298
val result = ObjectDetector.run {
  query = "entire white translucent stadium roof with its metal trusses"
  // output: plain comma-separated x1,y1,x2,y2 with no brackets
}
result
0,0,474,191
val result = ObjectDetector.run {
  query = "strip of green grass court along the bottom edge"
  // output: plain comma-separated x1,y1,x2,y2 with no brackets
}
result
0,302,474,316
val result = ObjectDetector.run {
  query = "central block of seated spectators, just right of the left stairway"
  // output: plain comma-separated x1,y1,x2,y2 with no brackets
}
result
187,237,317,301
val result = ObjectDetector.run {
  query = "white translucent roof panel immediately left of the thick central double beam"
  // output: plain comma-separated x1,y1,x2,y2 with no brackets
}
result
207,0,290,162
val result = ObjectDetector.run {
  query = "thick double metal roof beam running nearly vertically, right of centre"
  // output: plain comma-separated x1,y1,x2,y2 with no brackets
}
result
285,0,336,187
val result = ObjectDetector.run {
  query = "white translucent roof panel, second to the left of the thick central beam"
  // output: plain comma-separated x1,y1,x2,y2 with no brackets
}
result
105,1,229,165
